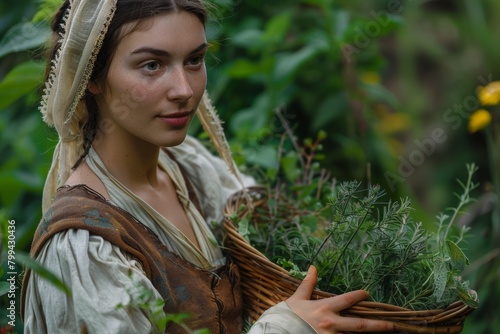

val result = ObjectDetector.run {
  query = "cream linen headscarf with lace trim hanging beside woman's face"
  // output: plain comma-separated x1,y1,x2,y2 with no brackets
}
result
40,0,243,213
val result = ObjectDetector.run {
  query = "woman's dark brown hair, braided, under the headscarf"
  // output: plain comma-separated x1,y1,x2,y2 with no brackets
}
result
46,0,208,169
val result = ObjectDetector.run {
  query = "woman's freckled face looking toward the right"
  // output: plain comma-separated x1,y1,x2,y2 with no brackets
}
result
89,12,207,146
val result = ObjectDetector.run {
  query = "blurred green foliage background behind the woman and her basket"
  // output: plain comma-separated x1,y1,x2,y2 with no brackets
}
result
0,0,500,333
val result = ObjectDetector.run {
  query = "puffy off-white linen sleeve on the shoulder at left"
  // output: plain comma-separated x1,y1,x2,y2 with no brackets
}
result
25,230,161,334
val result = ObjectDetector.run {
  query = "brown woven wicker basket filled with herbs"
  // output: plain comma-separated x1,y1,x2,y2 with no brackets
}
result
224,187,473,334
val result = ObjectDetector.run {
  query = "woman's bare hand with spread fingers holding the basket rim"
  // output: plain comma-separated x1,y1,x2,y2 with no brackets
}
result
286,266,394,334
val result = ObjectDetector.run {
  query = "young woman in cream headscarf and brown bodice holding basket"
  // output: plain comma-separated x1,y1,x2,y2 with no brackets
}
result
23,0,392,334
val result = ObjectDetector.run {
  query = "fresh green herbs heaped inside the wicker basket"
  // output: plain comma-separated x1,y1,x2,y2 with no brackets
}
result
238,134,478,310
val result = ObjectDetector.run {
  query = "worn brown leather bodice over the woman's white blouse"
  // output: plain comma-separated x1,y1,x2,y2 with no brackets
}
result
21,185,242,334
